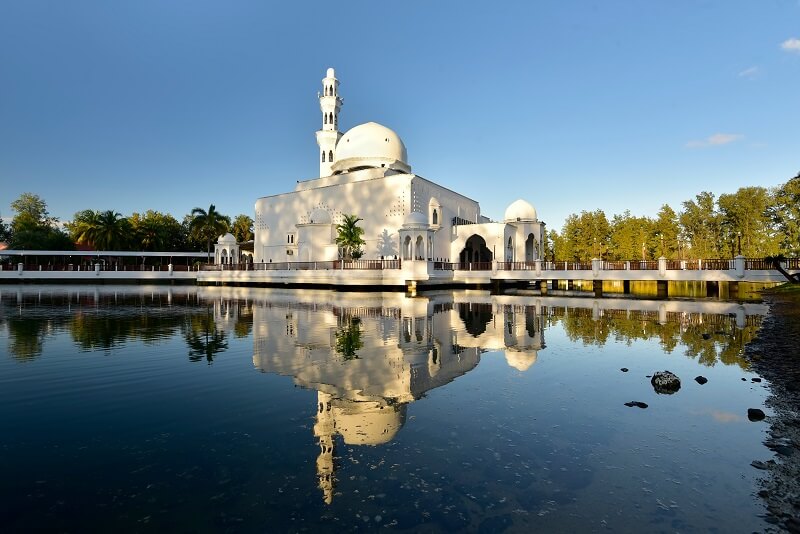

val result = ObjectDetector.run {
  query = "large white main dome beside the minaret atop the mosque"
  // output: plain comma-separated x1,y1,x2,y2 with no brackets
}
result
333,122,411,172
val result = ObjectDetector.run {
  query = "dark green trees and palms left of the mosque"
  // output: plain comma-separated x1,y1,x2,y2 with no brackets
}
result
0,193,253,253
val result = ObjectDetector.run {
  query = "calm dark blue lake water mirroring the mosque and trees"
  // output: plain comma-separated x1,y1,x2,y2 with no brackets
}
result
0,286,770,532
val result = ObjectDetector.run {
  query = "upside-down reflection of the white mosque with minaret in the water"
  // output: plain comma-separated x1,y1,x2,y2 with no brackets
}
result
219,292,544,503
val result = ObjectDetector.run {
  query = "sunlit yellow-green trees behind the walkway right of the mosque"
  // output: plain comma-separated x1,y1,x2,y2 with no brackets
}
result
546,173,800,262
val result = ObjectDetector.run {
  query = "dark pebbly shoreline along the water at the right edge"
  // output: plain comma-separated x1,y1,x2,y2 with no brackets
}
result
745,290,800,533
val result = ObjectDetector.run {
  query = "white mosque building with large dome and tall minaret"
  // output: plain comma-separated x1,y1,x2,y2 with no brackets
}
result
253,69,545,263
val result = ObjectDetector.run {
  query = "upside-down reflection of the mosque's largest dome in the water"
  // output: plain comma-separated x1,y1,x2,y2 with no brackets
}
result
333,399,406,445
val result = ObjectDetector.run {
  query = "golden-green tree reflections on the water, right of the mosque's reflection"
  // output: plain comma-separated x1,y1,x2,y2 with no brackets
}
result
549,308,760,369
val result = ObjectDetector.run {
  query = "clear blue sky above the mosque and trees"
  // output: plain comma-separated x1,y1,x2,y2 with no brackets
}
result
0,0,800,229
